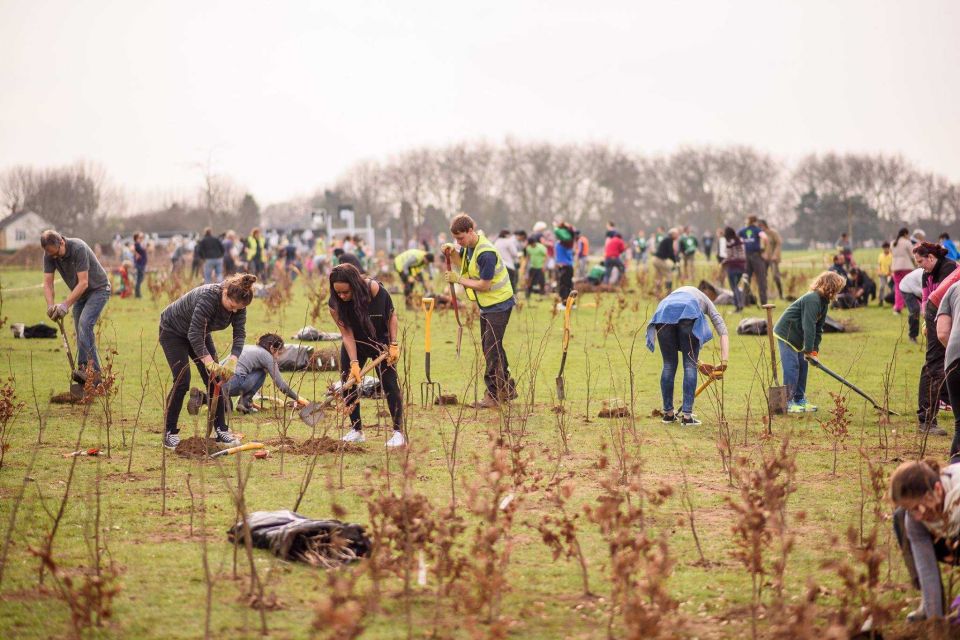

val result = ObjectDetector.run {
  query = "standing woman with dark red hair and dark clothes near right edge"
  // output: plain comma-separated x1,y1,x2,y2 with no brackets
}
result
913,242,957,436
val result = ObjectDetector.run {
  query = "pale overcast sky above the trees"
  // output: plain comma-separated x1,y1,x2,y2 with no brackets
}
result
0,0,960,204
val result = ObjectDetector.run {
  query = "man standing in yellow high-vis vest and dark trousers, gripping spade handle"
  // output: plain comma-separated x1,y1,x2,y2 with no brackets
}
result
443,213,517,409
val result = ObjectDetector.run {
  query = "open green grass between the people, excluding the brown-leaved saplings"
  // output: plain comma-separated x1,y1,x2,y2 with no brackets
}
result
0,254,932,638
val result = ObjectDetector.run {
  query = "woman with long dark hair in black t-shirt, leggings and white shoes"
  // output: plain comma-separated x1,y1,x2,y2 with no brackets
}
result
329,264,407,447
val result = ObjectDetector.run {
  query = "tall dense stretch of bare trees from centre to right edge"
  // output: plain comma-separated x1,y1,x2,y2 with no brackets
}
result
324,139,960,239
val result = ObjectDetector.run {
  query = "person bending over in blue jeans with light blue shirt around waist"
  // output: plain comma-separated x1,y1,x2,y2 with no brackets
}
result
647,287,730,426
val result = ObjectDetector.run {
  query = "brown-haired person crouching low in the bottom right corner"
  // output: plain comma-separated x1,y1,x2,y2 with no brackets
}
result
890,460,960,622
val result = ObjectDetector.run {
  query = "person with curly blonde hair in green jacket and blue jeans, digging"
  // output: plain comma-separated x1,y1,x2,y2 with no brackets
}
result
773,271,847,413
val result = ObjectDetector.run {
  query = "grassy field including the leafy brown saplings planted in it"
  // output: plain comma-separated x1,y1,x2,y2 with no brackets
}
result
0,254,952,638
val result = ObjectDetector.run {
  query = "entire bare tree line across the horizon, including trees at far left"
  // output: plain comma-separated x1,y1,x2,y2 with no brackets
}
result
0,139,960,245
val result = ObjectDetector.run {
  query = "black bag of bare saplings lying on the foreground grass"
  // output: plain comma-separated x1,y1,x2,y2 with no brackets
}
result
227,510,371,568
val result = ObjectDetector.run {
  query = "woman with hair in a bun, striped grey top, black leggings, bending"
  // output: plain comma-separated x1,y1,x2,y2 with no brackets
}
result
160,273,257,449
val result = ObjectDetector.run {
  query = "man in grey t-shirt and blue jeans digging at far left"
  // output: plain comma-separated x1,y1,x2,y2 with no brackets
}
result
40,229,110,382
